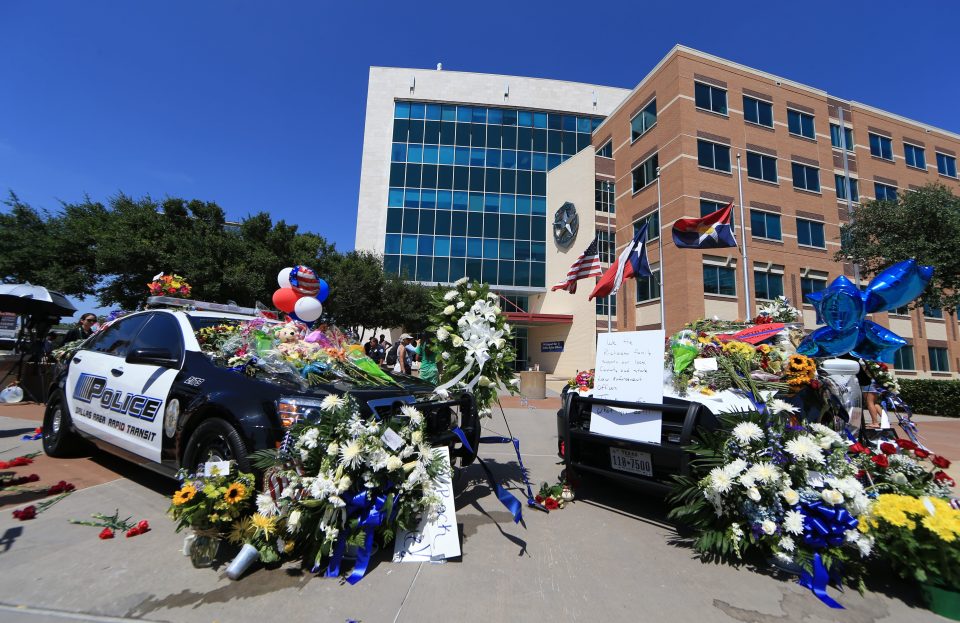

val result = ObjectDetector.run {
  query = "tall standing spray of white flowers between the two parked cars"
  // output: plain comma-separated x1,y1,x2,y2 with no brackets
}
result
428,278,518,416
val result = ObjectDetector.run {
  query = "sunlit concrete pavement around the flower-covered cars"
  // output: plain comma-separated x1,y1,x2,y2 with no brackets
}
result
0,399,960,623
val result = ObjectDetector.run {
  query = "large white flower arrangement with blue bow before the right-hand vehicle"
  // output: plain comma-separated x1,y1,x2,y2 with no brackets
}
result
669,408,873,601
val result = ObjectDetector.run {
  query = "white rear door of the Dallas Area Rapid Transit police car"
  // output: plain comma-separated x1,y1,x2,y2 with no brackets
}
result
64,313,152,447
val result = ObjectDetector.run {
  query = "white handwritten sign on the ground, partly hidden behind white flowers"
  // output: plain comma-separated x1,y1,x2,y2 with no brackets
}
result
393,446,460,562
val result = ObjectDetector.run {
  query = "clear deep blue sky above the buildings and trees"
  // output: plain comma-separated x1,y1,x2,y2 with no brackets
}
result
0,0,960,260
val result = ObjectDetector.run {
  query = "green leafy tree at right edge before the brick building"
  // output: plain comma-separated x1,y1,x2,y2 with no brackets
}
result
835,184,960,312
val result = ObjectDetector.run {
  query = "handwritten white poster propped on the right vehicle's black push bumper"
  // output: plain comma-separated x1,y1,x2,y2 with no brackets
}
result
590,330,664,443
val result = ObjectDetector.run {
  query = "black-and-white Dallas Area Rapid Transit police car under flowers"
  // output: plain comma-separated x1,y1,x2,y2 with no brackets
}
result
43,297,480,475
